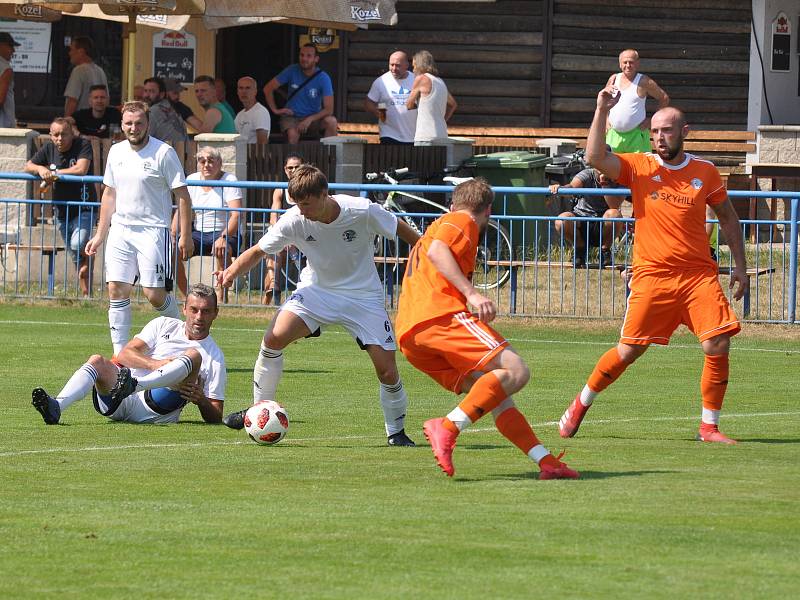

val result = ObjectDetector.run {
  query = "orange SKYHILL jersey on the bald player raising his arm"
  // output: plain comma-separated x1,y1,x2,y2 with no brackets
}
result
617,153,728,270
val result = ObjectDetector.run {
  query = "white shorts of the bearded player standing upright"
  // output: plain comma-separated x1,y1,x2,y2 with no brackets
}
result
106,223,173,291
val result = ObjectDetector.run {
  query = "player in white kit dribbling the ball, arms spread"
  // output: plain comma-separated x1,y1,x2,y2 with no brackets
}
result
217,165,419,446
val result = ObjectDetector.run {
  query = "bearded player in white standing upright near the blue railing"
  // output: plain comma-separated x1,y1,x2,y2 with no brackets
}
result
86,102,194,354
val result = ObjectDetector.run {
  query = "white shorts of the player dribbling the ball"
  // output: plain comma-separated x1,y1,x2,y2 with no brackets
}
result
281,284,397,350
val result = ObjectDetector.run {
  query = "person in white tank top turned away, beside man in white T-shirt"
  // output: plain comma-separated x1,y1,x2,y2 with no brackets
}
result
406,50,458,144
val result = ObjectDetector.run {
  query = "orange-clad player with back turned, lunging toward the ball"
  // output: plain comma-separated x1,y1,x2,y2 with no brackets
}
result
395,179,578,479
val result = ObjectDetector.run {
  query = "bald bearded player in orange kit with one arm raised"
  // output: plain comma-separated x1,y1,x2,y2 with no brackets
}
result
559,87,749,444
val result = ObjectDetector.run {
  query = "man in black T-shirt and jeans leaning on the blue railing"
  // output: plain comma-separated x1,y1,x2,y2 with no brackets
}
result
25,117,97,296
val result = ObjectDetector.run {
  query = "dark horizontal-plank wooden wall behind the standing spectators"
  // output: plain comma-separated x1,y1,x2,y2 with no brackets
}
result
346,0,752,130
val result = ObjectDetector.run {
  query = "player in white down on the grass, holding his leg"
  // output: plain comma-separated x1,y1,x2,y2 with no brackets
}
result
32,284,227,425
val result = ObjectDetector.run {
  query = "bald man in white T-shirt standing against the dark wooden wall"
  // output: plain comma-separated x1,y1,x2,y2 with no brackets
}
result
364,50,417,144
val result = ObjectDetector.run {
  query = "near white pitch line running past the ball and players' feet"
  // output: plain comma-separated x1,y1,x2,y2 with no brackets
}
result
0,411,800,457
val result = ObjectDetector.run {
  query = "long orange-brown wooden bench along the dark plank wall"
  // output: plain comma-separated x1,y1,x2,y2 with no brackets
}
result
339,123,756,177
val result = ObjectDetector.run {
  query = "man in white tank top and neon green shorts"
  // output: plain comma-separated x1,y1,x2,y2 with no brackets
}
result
606,50,669,152
